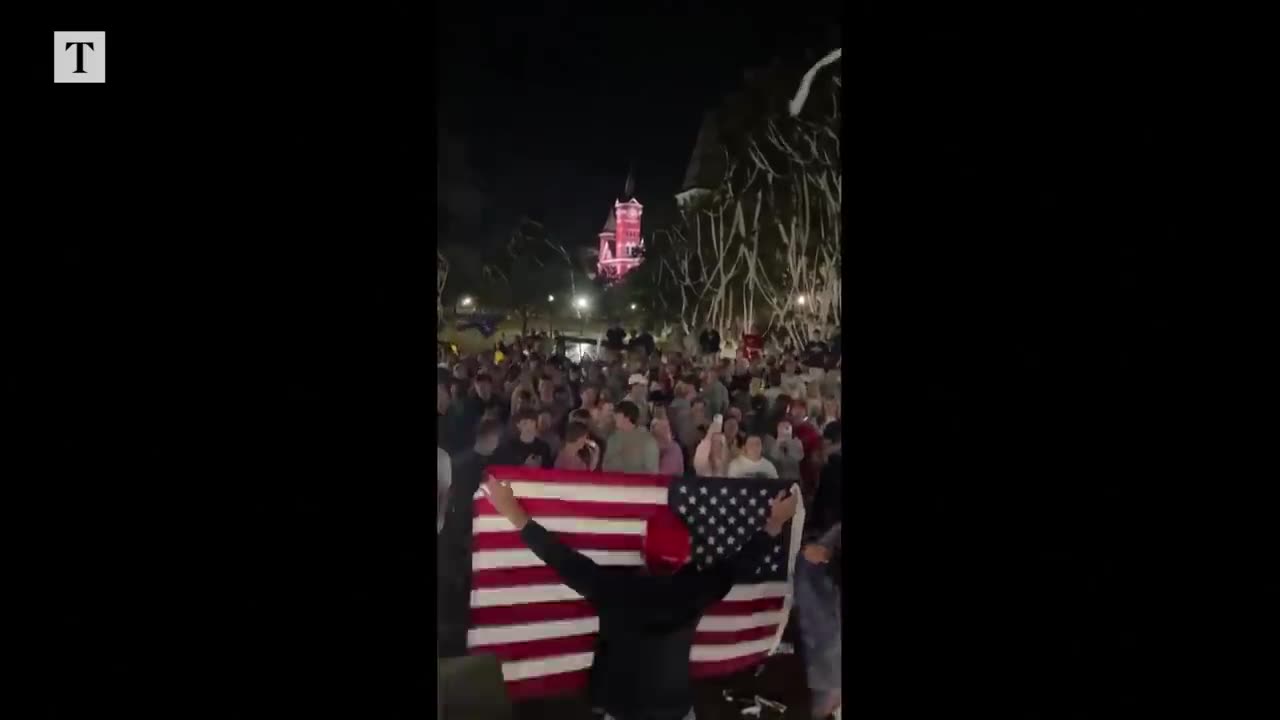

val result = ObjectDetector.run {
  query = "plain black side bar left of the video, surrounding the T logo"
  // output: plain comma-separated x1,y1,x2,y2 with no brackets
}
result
8,8,424,719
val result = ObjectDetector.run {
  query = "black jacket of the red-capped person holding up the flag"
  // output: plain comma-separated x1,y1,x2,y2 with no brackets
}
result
521,520,772,720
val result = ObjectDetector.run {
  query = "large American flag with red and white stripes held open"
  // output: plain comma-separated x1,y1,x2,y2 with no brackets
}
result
467,466,804,700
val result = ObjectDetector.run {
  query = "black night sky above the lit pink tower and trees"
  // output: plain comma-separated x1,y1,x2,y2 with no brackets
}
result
438,1,840,245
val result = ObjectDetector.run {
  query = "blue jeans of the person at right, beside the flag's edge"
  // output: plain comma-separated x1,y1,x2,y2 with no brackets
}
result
795,555,840,692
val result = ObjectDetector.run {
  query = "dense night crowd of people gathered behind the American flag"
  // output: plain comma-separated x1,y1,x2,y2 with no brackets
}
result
436,328,844,717
